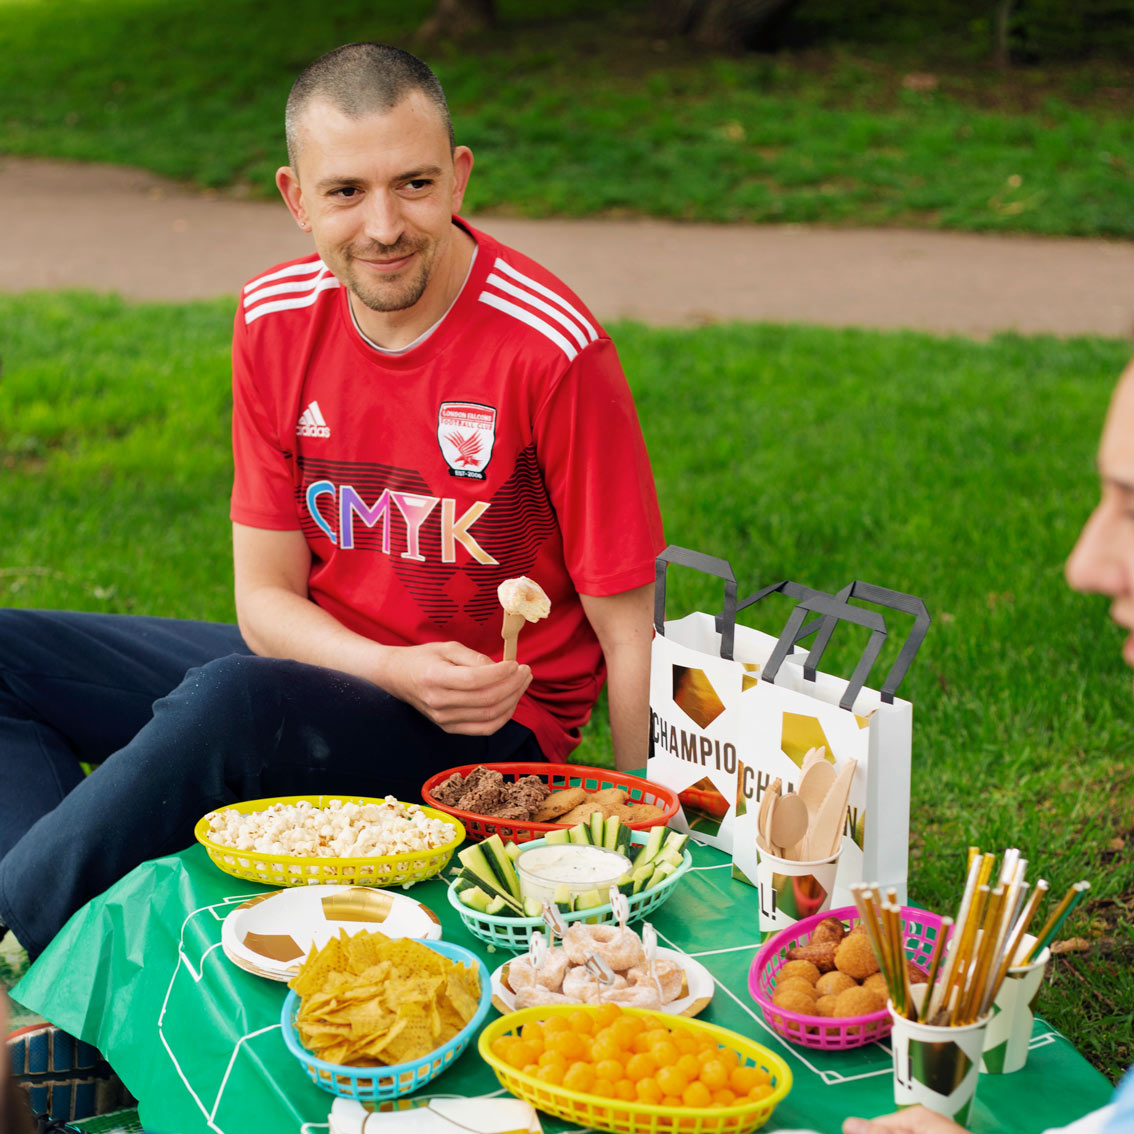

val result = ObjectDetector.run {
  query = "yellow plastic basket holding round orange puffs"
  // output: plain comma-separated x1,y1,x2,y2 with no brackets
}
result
477,1004,792,1134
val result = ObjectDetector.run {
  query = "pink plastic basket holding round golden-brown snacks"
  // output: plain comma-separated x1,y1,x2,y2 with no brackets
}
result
748,906,941,1051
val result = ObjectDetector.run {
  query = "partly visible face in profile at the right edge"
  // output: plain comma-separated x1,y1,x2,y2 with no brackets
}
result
1067,364,1134,666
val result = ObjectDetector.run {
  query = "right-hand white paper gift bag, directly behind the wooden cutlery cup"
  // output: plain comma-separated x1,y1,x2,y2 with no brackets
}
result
733,581,929,907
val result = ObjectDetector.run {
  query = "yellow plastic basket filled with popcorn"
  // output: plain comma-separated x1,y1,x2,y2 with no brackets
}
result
193,795,465,887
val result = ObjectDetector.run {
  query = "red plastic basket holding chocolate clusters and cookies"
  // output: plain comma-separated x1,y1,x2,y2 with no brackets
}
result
422,763,679,843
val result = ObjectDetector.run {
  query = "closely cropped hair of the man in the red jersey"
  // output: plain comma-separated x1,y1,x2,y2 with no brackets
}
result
285,43,454,169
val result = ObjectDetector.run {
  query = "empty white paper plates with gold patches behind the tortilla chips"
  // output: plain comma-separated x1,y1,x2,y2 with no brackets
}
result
220,883,441,981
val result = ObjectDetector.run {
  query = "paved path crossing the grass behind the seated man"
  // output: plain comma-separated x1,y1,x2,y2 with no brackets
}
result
8,158,1134,338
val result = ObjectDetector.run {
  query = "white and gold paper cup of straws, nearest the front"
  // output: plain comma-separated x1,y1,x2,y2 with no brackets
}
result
887,984,991,1126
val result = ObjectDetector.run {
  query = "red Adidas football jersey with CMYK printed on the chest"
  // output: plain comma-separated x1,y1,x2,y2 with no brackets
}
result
231,219,663,761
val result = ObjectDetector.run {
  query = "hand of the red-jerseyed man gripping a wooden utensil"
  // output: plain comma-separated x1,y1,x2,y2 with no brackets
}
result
379,642,532,736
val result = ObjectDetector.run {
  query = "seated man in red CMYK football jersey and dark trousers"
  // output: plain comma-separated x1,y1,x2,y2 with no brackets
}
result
0,43,663,956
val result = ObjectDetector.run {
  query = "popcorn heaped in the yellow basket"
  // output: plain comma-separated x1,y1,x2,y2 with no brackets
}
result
205,795,452,858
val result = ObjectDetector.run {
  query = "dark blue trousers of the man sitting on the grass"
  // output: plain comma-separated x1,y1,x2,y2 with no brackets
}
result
0,610,543,958
